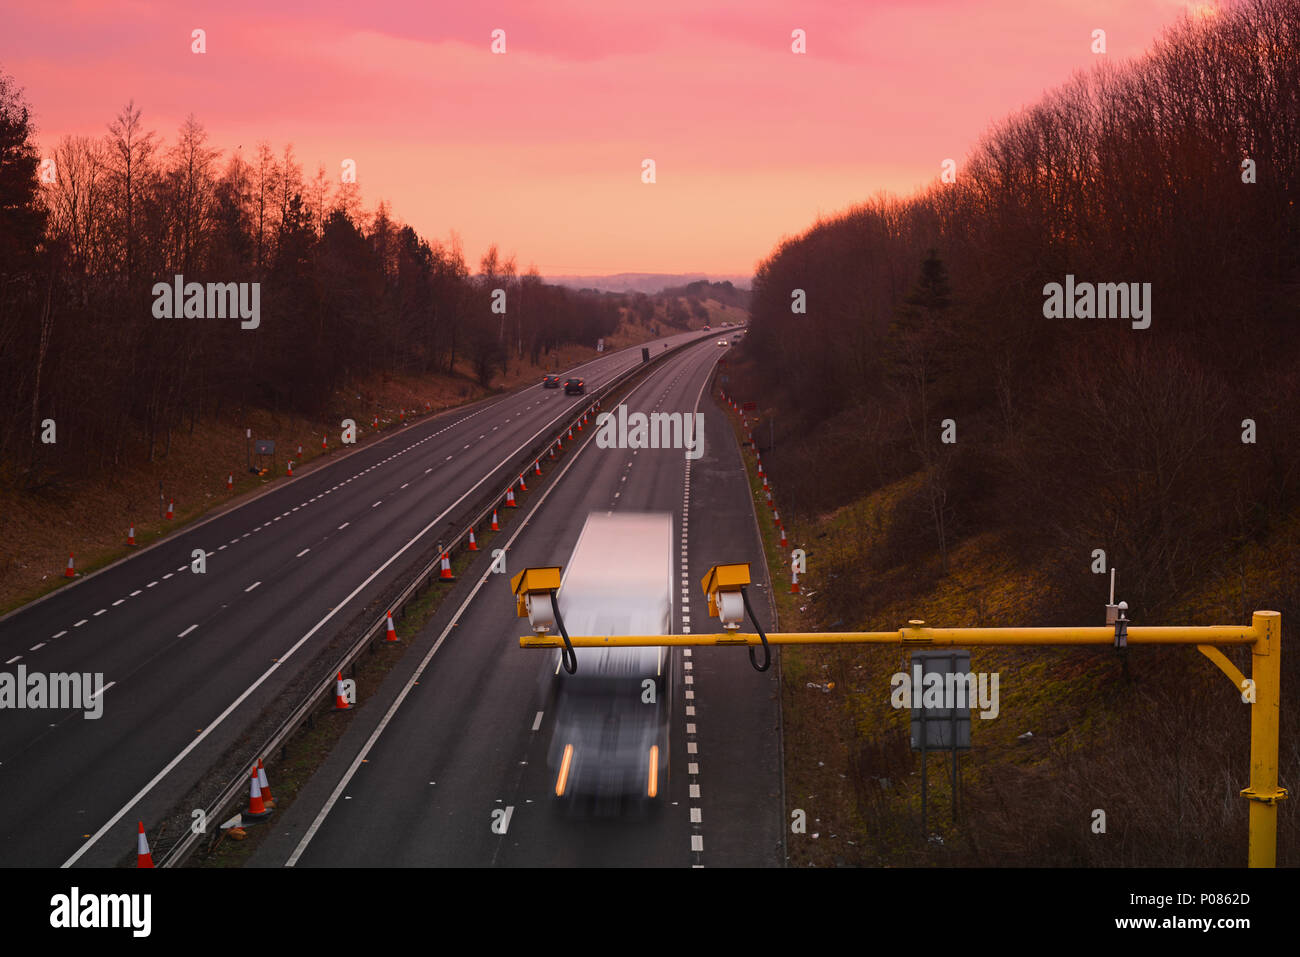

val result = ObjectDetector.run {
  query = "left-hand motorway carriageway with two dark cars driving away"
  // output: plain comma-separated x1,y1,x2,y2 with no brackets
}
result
0,328,702,866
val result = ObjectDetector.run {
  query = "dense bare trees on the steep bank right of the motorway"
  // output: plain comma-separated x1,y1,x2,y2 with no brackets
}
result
745,0,1300,620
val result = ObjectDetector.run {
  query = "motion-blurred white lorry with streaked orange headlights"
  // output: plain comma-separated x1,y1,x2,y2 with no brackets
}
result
547,512,673,800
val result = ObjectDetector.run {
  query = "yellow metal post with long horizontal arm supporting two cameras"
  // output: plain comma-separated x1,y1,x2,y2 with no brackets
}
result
516,613,1287,867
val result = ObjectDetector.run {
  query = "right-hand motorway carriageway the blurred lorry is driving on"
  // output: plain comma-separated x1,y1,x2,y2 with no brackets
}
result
252,342,784,867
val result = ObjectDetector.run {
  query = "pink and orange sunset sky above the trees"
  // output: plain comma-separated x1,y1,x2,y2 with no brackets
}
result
0,0,1201,276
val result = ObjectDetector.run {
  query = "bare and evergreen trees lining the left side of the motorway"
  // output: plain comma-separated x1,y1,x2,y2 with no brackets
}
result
0,85,627,484
